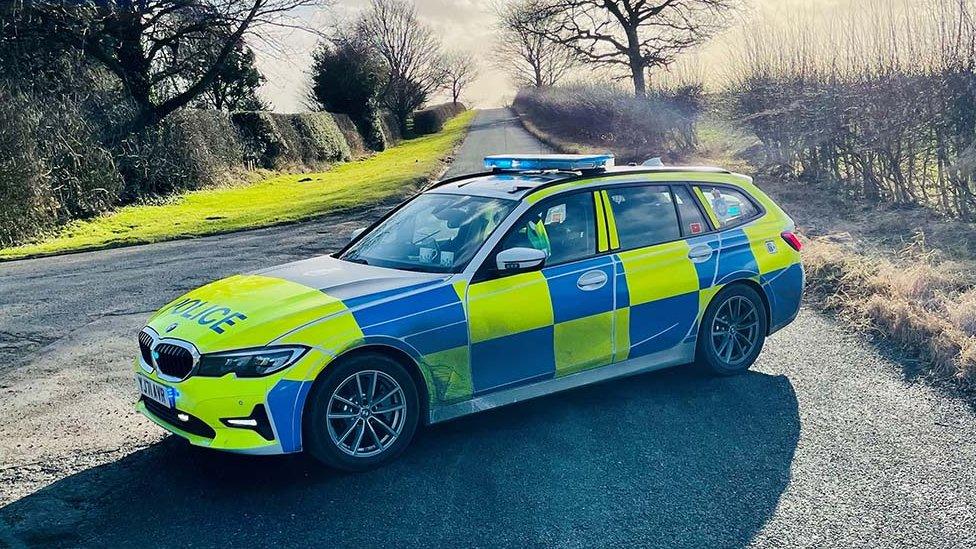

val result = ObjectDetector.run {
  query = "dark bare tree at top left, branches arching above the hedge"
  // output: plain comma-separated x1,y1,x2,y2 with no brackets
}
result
17,0,329,130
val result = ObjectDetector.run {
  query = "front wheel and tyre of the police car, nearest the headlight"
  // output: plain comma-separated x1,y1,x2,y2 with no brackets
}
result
303,353,420,471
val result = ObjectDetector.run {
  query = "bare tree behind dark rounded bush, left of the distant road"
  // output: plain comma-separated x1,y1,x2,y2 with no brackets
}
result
359,0,447,130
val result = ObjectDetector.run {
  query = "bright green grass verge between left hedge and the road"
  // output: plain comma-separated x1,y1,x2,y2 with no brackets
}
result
0,111,474,261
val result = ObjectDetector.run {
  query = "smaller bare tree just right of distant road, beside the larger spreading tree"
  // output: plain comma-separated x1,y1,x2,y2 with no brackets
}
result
494,0,579,88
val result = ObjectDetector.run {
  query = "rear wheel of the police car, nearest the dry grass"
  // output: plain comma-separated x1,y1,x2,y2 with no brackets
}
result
695,285,769,375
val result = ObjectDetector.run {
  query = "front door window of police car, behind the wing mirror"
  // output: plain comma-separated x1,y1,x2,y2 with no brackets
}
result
500,192,596,265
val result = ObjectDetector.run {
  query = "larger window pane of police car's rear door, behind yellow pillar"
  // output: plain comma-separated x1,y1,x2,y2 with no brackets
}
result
607,185,681,250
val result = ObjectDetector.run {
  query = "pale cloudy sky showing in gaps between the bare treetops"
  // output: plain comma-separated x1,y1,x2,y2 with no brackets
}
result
256,0,844,112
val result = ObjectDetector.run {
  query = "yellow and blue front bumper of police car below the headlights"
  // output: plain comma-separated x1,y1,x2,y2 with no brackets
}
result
135,349,328,454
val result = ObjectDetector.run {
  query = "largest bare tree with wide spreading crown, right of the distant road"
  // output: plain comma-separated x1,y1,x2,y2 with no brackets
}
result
526,0,735,97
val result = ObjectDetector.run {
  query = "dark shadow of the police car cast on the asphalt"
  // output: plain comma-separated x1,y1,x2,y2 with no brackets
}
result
0,368,800,547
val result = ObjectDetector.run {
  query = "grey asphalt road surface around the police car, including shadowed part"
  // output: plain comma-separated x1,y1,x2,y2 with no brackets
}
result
0,110,976,548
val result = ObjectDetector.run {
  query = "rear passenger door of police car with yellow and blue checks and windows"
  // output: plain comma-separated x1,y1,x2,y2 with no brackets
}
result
602,183,715,362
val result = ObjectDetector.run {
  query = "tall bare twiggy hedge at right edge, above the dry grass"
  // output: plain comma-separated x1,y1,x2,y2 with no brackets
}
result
728,2,976,221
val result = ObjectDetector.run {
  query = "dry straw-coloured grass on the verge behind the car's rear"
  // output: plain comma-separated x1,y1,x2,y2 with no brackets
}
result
803,236,976,390
